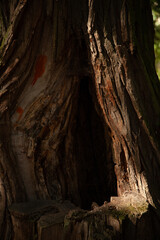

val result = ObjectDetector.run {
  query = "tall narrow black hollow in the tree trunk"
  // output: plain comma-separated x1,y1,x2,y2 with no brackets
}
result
70,77,117,209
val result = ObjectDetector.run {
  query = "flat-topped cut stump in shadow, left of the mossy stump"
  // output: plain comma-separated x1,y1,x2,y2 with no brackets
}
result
10,200,75,240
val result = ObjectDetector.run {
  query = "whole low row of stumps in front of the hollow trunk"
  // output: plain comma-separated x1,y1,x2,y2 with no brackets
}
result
10,193,160,240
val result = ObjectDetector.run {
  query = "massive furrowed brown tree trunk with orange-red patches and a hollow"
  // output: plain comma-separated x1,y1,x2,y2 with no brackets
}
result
0,0,160,240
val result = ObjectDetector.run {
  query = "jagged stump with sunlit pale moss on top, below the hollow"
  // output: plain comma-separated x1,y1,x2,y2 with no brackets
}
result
64,193,160,240
